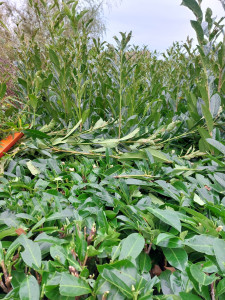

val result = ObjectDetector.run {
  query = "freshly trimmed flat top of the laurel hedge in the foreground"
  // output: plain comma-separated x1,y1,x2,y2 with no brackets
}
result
0,140,225,299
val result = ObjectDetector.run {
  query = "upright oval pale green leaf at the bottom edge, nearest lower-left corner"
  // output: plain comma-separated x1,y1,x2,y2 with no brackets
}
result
19,275,40,300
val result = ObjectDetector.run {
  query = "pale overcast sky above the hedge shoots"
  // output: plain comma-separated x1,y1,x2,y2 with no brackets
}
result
104,0,225,51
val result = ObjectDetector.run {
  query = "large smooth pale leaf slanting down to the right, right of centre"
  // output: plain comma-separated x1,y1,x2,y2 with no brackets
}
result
147,207,181,232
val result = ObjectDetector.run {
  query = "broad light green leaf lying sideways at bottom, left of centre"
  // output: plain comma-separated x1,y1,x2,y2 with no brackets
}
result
59,273,91,297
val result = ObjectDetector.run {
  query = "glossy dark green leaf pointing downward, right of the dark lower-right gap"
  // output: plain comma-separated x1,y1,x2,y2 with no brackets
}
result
163,248,188,272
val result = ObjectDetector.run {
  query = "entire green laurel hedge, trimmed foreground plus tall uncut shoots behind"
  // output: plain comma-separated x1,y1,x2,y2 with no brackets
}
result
0,0,225,300
